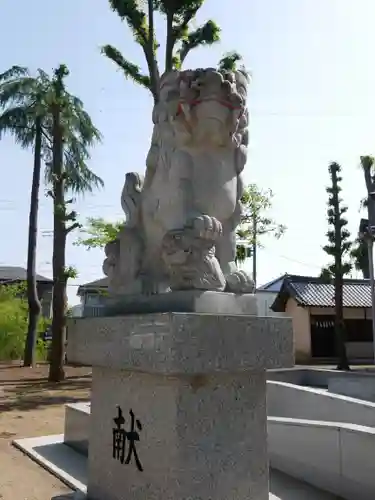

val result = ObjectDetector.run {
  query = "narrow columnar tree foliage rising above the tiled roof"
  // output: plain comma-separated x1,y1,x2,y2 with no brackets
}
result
321,163,352,280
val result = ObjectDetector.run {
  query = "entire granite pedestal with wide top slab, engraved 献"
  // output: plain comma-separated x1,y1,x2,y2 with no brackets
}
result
68,313,293,500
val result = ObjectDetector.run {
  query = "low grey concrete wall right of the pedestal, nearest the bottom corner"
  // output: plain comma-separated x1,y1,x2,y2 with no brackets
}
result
268,417,375,500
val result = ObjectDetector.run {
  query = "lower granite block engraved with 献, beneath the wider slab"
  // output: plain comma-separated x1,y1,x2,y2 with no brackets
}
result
88,368,269,500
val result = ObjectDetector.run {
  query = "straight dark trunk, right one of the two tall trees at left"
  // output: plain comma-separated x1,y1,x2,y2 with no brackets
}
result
48,100,66,382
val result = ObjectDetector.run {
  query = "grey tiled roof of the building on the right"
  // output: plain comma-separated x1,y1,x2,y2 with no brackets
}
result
271,274,371,312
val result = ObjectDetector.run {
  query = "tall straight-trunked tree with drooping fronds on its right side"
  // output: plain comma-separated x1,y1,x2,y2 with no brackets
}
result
48,65,103,382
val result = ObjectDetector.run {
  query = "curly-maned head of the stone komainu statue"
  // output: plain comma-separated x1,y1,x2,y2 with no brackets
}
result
160,68,249,149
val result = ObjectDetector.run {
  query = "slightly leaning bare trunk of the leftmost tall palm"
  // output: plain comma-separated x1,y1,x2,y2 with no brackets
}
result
23,117,42,366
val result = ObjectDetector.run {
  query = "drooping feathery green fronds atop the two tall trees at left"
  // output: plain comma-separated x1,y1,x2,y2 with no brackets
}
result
0,65,103,193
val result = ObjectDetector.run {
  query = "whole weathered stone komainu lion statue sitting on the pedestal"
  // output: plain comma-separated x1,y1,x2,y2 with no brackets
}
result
103,68,254,294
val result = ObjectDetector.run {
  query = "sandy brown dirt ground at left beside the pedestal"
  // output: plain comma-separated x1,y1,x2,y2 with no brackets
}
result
0,364,91,500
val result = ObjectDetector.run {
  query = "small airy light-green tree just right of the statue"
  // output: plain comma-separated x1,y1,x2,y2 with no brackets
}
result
237,184,286,262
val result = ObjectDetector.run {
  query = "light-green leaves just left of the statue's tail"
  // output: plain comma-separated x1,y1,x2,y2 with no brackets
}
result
74,217,124,250
